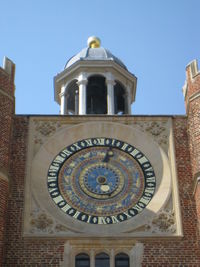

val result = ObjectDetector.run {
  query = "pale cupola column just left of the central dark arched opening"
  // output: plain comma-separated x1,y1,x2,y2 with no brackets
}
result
77,73,88,115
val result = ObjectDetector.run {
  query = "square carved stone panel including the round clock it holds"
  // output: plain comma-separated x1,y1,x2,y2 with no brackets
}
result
24,117,182,238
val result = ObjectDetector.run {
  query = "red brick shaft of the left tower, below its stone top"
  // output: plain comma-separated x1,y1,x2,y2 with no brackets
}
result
0,68,14,266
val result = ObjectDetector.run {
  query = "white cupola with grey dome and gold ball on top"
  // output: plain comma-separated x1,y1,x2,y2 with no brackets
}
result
54,36,137,115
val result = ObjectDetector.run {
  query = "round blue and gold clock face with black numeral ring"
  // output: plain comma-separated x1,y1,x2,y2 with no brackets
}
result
47,137,156,225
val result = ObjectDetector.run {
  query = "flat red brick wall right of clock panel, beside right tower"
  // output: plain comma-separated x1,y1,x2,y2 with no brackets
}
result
143,118,200,266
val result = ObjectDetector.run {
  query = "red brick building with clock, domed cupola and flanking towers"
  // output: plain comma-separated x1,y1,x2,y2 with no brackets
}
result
0,37,200,267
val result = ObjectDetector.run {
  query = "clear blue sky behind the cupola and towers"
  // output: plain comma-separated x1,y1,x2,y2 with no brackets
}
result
0,0,200,115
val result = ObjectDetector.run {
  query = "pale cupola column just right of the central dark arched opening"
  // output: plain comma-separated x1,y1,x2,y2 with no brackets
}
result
106,75,115,115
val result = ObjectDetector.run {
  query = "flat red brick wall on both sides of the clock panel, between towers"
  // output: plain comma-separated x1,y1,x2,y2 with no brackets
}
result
3,116,200,267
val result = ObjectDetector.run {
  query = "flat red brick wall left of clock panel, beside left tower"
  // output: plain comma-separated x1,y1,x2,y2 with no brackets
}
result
3,117,64,267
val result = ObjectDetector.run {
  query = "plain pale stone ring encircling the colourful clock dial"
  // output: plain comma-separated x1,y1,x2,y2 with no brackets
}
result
31,122,171,236
